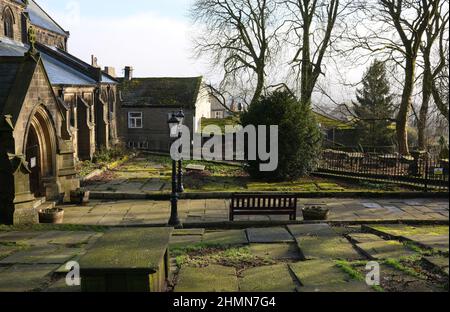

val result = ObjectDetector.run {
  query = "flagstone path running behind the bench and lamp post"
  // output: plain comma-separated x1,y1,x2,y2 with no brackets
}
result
58,198,449,227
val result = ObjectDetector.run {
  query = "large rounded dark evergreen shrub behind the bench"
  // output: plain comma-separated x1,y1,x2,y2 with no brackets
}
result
241,91,322,180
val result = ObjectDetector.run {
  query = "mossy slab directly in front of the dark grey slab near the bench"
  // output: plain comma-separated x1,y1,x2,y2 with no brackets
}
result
250,243,301,260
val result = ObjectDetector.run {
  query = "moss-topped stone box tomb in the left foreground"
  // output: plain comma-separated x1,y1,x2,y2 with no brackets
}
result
79,228,172,292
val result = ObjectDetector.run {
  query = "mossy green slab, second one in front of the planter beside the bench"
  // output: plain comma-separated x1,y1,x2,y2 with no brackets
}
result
297,236,362,260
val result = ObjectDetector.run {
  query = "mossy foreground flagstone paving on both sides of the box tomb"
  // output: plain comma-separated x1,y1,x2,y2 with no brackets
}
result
0,223,448,292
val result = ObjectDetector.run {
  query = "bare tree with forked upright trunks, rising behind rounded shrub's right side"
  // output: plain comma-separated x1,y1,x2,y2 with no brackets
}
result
286,0,349,104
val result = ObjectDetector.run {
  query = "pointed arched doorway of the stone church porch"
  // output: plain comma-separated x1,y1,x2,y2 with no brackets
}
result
25,106,56,197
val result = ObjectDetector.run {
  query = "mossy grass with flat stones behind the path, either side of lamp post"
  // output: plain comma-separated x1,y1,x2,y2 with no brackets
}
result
81,154,414,192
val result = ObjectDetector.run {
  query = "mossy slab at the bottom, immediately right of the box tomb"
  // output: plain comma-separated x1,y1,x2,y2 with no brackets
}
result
174,265,239,292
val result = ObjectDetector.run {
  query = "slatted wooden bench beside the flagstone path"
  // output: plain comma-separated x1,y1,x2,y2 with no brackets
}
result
230,193,297,221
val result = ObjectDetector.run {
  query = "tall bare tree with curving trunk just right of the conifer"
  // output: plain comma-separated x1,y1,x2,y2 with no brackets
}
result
352,0,441,154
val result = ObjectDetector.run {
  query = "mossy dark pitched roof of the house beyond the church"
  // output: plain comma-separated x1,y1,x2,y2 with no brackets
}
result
119,77,203,109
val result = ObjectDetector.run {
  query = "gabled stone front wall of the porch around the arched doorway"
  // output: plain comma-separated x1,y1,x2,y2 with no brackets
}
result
0,56,79,224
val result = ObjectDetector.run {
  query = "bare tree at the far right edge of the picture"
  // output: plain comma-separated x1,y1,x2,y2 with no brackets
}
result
417,0,449,150
